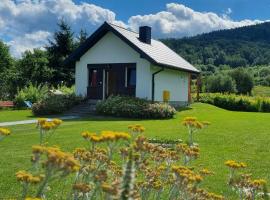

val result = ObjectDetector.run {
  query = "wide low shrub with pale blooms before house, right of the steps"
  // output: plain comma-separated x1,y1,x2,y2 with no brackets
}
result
96,96,176,119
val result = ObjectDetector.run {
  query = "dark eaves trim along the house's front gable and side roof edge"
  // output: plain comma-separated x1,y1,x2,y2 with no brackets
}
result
64,22,200,74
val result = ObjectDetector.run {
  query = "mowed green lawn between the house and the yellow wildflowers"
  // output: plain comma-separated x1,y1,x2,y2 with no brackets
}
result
0,103,270,199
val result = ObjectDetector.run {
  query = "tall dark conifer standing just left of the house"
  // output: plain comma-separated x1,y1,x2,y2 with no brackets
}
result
46,19,75,85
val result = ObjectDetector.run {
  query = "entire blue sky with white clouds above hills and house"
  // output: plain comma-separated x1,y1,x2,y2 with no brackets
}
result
0,0,270,57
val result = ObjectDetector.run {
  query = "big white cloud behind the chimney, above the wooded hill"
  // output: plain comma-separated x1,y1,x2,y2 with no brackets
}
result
128,3,263,37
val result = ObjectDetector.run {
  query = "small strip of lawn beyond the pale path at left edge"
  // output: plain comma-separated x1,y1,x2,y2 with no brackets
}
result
0,110,34,122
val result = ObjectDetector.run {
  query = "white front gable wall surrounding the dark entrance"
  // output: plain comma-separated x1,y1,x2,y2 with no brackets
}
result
75,32,151,99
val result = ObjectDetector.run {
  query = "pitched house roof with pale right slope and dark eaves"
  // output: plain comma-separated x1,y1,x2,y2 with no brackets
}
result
65,22,200,73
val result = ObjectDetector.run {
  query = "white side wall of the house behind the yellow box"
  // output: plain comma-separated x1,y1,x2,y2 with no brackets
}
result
151,66,188,102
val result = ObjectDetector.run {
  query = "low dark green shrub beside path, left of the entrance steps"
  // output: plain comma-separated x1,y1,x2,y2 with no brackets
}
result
32,94,82,116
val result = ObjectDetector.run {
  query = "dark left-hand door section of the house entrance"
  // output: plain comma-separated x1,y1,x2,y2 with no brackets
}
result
87,67,103,99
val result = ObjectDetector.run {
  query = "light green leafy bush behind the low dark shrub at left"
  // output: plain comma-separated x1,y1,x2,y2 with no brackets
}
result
14,84,49,107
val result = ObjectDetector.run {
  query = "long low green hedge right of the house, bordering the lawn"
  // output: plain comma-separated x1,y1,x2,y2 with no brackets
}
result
199,93,270,112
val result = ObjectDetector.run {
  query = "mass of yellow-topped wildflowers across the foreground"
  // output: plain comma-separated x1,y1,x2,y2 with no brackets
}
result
16,121,266,200
